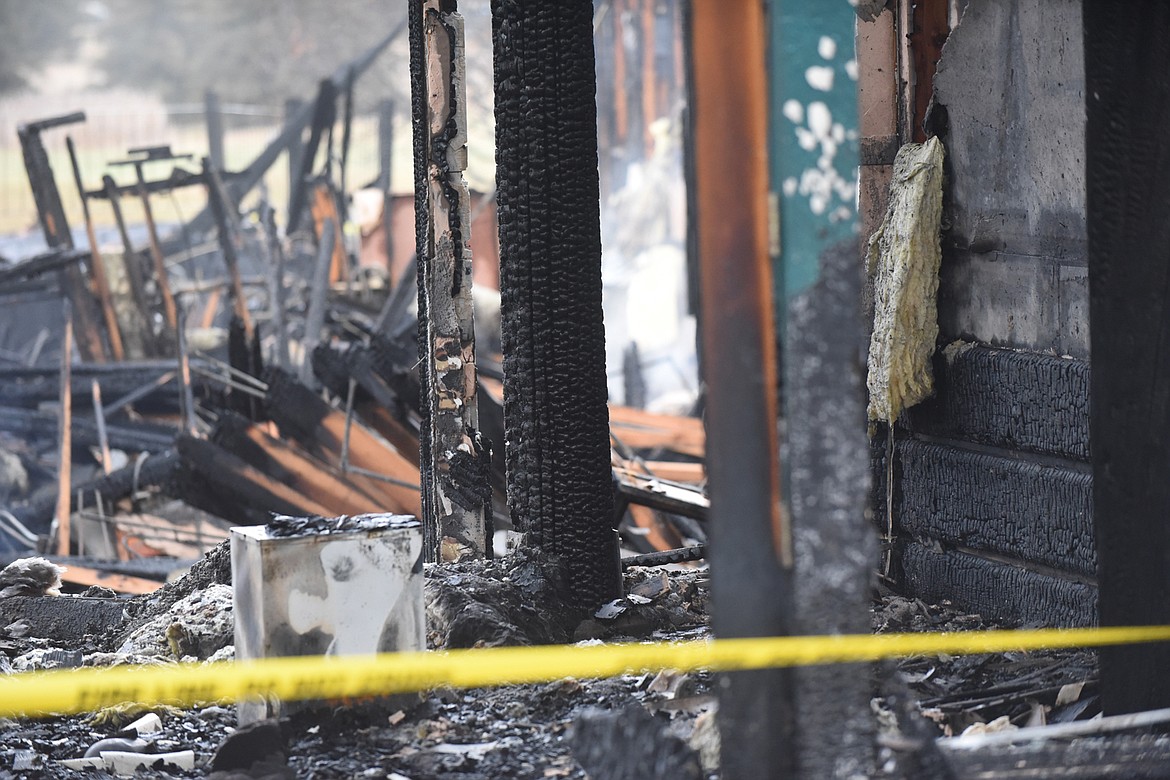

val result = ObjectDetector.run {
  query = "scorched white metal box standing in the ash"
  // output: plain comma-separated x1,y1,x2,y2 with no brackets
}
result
232,515,426,724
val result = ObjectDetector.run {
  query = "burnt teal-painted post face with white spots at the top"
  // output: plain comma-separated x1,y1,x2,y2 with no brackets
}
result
772,0,875,778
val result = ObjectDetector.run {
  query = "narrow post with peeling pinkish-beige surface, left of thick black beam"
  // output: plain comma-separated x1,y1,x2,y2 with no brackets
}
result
411,0,491,559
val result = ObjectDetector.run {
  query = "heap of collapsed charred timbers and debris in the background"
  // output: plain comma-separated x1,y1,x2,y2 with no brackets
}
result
0,39,707,593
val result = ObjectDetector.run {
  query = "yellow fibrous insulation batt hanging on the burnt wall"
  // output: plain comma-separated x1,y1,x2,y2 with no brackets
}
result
866,138,943,421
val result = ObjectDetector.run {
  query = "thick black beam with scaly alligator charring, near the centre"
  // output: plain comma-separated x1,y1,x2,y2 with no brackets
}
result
491,0,621,607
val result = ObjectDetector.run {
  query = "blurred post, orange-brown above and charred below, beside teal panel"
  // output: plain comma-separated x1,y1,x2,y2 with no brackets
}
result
687,0,797,780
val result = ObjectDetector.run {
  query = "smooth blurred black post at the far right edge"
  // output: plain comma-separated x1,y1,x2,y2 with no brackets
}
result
1085,0,1170,715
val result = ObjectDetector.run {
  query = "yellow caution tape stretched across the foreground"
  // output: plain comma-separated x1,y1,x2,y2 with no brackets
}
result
0,626,1170,717
